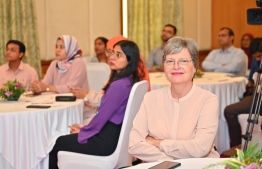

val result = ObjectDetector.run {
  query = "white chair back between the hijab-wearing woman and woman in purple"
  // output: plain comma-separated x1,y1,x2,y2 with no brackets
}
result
85,62,111,92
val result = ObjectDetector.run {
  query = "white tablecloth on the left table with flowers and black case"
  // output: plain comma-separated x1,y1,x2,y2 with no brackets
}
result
0,94,83,169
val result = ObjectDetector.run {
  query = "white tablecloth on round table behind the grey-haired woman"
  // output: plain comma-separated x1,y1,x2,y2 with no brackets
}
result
149,72,247,153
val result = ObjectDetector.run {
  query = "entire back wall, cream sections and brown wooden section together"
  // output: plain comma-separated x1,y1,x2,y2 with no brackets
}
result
35,0,262,60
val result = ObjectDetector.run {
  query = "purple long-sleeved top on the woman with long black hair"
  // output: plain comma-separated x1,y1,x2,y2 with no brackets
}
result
78,77,132,144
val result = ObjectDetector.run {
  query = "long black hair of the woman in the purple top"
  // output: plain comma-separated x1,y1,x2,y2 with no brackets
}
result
103,40,143,91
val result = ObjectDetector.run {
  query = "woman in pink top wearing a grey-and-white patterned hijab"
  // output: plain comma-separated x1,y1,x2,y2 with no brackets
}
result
31,35,89,93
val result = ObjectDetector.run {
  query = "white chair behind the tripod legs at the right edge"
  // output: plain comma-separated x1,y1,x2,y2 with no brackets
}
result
238,114,262,149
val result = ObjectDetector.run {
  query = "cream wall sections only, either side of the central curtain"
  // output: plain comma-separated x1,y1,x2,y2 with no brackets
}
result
35,0,211,60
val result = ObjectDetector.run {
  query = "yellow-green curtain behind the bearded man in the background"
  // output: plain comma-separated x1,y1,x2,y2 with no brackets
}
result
127,0,183,62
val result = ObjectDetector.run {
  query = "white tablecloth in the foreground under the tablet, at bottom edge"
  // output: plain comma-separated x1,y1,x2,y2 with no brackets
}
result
128,158,226,169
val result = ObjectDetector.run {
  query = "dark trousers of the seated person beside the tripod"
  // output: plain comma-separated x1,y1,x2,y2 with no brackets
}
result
224,96,253,147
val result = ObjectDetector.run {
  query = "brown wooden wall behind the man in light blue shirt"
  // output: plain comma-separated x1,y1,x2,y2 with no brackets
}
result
212,0,262,49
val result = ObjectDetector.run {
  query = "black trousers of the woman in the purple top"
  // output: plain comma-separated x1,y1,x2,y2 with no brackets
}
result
49,122,122,169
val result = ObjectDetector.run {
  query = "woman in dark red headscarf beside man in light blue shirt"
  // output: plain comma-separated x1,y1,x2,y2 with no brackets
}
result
241,33,254,69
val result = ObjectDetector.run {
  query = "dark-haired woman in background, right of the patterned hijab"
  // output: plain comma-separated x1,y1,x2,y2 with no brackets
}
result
91,37,108,63
